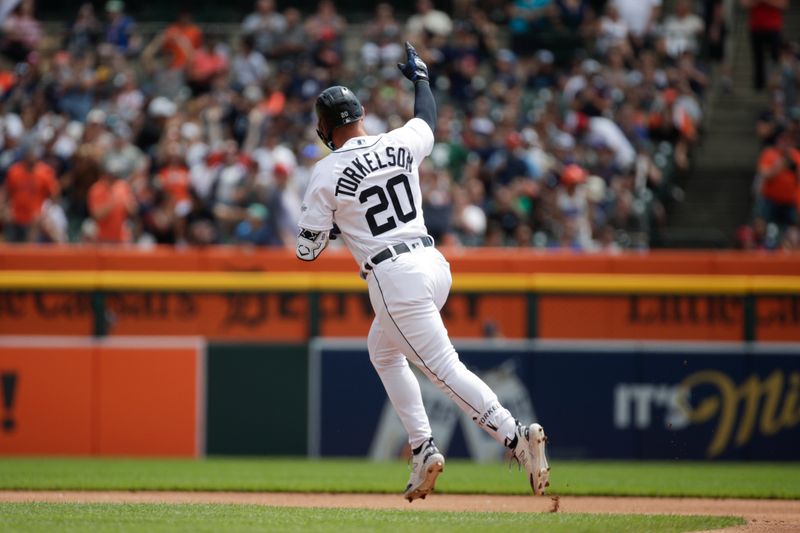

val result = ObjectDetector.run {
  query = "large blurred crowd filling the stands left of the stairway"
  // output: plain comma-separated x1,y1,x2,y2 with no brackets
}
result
0,0,722,250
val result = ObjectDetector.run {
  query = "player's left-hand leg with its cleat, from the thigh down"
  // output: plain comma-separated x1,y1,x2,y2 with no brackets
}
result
367,319,444,502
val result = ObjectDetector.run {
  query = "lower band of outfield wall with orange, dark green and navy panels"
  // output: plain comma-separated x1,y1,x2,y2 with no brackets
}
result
0,336,800,461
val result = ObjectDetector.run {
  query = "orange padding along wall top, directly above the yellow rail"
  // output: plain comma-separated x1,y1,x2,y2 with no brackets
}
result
0,244,800,276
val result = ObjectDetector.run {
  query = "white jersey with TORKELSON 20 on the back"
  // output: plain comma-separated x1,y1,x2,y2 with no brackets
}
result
298,118,433,265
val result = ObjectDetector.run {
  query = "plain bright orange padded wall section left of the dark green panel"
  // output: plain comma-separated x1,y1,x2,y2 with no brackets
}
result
0,337,203,457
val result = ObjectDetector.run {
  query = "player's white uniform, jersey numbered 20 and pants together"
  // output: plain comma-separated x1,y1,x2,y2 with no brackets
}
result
297,118,516,449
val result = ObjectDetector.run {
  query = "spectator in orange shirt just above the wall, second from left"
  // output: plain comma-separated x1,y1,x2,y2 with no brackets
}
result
88,158,137,243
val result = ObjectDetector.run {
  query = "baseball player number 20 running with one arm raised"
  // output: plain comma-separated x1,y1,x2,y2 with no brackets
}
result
297,43,550,502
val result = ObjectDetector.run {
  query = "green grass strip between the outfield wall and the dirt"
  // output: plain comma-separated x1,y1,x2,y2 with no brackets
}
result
0,458,800,499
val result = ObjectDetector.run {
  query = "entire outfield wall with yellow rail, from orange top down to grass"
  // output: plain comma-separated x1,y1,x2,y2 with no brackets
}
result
0,245,800,460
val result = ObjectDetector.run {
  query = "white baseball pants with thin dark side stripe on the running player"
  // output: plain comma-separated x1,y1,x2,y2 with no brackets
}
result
367,247,516,449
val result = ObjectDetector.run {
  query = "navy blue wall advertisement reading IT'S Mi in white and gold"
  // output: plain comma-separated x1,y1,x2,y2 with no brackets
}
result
309,340,800,460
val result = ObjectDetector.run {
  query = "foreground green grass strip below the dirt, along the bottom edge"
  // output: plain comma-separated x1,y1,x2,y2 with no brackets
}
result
0,503,743,533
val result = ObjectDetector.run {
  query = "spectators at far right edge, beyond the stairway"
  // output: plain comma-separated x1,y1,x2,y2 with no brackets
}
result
737,0,800,250
